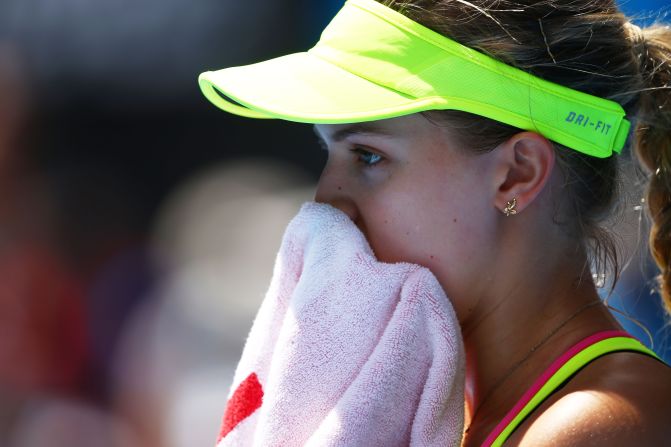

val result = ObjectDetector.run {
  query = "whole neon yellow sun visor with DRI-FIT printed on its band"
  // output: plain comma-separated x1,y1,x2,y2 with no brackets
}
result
199,0,630,158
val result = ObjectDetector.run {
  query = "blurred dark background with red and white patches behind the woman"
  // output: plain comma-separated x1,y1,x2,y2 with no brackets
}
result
0,0,671,447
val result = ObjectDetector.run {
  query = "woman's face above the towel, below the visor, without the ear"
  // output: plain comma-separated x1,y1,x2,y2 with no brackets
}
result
315,114,500,318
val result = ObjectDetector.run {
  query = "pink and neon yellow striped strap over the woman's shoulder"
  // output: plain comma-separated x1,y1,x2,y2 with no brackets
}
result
483,331,660,447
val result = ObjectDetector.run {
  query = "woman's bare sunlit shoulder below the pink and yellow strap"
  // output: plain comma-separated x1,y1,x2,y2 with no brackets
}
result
506,352,671,447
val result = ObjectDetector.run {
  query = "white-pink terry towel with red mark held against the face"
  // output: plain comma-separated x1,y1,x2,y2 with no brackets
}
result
218,203,465,447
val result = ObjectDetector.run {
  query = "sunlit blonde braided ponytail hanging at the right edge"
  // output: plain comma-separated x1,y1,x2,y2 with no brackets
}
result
627,24,671,314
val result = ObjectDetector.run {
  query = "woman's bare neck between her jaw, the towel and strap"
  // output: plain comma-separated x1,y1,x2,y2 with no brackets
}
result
462,242,619,445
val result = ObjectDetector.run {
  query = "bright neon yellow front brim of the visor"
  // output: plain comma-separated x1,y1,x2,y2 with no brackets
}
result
198,52,445,124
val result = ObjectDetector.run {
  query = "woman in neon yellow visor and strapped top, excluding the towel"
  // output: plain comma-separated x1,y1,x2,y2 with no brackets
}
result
201,0,671,446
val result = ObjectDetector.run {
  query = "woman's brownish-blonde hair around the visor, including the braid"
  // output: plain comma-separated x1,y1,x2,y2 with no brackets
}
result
378,0,671,313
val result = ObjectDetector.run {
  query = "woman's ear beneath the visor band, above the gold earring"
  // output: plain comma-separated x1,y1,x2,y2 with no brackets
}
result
494,132,555,212
